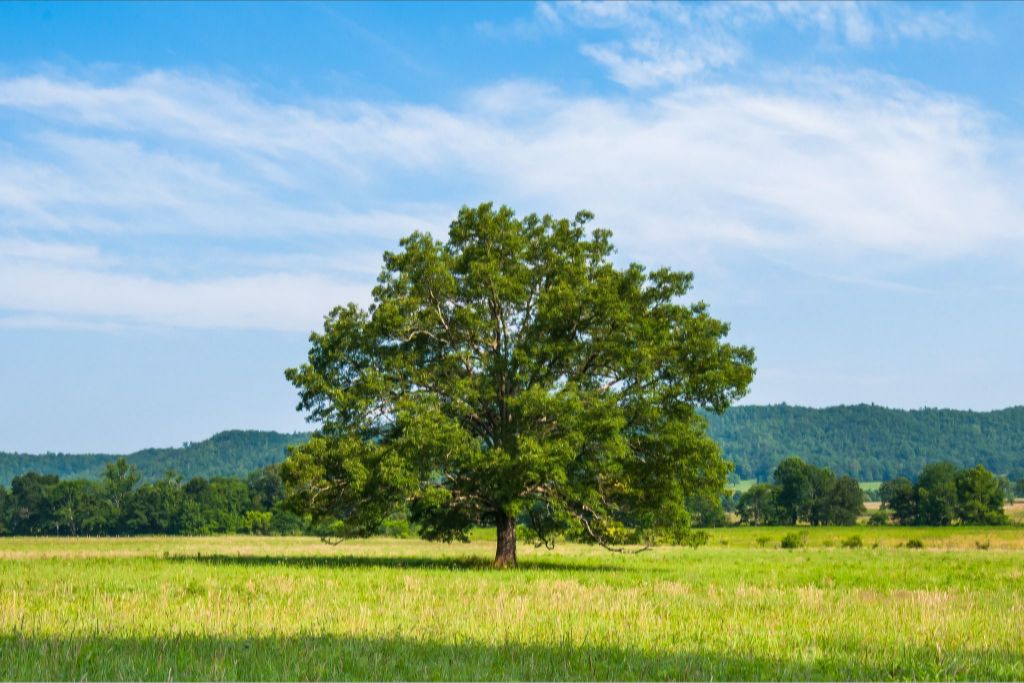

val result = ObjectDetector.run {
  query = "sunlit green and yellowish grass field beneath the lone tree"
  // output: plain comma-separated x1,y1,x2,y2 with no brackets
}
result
0,527,1024,680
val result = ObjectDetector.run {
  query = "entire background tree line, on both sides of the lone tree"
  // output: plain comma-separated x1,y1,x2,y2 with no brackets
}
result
0,458,1014,540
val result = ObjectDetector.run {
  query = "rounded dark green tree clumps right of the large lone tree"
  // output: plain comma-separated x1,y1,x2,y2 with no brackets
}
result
720,458,1015,526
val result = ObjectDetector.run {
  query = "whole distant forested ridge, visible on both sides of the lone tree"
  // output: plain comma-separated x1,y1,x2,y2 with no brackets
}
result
8,403,1024,485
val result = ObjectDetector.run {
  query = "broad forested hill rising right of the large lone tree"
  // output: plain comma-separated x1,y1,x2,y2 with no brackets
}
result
708,403,1024,481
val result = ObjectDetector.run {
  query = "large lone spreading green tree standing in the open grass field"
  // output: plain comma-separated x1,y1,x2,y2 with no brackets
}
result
282,204,754,566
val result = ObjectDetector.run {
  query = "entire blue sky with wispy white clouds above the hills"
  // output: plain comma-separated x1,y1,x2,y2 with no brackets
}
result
0,2,1024,453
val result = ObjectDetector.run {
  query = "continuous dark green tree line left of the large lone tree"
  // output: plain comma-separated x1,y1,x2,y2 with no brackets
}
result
0,458,308,536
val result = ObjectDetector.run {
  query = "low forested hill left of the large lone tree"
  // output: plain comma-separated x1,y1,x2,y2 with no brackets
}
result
0,431,309,486
